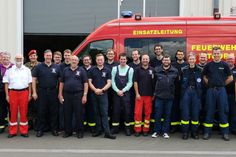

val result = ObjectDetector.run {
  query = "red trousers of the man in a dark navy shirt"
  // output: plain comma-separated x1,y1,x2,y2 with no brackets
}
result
134,96,152,133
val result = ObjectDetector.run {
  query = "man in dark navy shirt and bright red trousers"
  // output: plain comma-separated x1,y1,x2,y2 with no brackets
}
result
134,54,155,137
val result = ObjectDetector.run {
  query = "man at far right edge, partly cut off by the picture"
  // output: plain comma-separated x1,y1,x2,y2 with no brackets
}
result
226,53,236,134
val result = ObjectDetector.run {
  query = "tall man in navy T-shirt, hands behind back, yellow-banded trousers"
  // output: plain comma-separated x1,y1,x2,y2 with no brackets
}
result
203,47,233,141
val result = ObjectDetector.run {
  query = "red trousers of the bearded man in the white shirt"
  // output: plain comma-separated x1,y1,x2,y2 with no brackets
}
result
9,90,29,135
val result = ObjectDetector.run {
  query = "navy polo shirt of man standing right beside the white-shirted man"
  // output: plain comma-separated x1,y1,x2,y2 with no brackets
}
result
32,63,60,88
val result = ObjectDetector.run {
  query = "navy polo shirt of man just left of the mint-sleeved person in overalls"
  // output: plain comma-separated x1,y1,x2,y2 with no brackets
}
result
88,66,111,89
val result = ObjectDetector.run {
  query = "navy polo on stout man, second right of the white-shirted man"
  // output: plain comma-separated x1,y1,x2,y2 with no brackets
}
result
61,67,88,93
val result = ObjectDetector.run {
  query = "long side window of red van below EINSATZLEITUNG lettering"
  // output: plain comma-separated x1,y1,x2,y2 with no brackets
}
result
125,38,186,60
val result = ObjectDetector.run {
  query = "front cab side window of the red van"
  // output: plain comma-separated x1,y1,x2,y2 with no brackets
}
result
78,40,114,63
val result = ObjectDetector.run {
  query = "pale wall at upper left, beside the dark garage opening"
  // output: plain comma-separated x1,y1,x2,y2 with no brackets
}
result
0,0,23,58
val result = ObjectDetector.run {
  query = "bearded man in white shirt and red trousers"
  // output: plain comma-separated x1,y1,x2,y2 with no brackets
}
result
3,54,32,138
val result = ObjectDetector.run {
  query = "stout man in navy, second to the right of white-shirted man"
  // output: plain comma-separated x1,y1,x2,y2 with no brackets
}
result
58,56,88,138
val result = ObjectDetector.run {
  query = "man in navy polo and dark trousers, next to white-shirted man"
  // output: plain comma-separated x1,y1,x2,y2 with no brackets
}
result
32,49,60,137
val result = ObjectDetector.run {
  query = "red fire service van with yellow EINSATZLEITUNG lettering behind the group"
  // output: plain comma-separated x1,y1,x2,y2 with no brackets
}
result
74,12,236,62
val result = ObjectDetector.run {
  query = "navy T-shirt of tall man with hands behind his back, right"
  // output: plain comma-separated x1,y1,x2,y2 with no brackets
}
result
202,61,231,87
